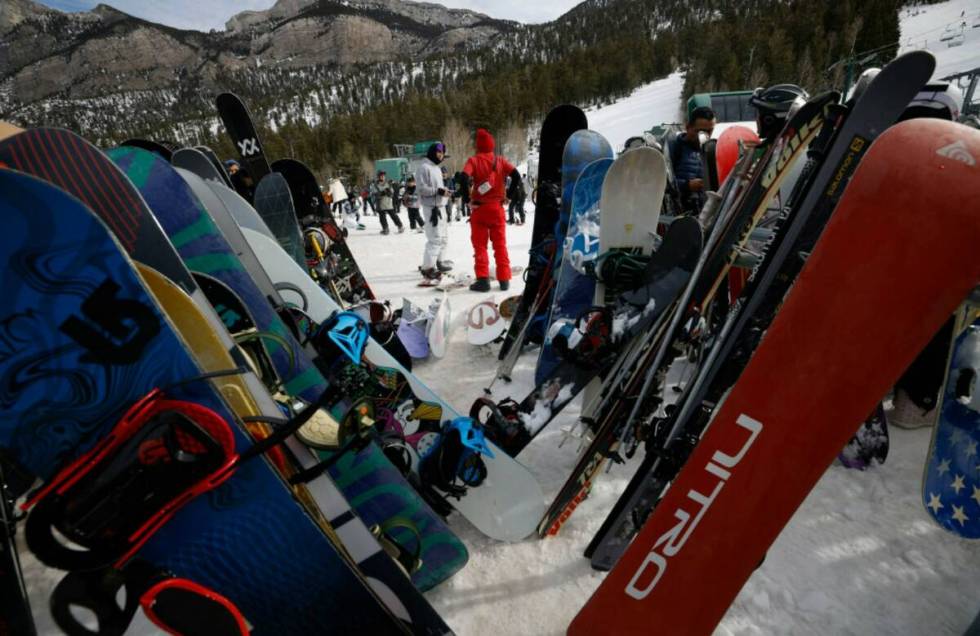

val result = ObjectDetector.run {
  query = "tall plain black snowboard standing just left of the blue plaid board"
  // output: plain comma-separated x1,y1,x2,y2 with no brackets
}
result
498,104,588,362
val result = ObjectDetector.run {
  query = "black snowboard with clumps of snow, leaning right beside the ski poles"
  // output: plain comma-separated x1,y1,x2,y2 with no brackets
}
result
470,217,702,457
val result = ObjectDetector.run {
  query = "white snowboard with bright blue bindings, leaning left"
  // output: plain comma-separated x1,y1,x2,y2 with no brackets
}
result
242,229,544,541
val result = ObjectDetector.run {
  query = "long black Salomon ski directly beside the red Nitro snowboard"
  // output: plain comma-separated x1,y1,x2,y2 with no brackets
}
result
586,51,935,570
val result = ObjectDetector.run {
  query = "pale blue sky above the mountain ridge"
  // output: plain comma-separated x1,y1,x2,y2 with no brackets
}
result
39,0,582,31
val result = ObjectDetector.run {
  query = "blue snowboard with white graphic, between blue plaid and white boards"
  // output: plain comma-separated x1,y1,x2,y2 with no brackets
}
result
534,158,613,384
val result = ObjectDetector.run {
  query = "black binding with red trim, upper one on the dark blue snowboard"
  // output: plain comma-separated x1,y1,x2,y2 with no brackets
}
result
24,390,238,571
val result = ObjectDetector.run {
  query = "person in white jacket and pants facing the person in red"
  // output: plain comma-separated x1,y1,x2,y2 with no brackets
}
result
415,142,452,278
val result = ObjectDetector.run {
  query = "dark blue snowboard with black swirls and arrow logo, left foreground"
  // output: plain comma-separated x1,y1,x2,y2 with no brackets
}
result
0,166,405,634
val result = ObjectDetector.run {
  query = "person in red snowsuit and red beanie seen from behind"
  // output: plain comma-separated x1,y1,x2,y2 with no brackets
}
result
463,128,521,291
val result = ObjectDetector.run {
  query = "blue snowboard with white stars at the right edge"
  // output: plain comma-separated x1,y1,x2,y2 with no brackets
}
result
922,300,980,539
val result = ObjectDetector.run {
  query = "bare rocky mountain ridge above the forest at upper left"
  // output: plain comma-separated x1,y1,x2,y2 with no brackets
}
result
0,0,519,134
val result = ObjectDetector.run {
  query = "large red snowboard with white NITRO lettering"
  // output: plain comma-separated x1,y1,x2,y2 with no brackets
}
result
569,119,980,636
